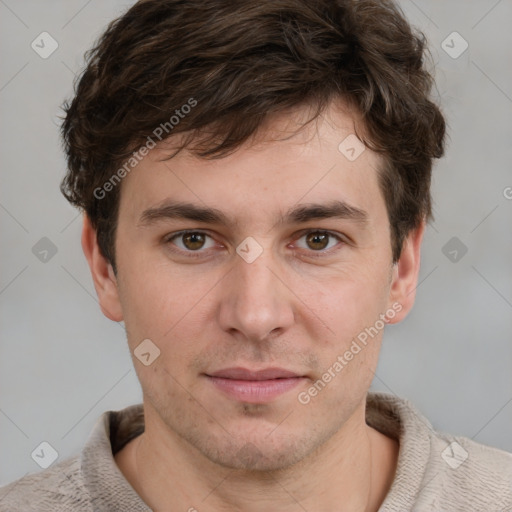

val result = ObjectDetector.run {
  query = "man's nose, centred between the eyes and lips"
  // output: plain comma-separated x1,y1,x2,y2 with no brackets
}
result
219,245,294,342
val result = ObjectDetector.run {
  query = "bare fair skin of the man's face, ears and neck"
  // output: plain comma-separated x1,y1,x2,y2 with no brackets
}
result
82,103,425,512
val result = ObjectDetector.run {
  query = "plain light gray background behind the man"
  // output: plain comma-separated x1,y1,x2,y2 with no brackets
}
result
0,0,512,485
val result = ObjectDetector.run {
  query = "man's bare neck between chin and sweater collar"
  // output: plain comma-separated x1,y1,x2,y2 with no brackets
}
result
115,404,398,512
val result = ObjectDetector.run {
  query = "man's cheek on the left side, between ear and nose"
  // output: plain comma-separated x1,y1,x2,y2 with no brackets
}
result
116,264,219,389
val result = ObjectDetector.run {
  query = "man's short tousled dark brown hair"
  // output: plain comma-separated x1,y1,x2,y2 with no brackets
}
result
61,0,445,271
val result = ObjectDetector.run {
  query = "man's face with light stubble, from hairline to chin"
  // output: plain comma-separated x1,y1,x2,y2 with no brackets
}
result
86,100,421,470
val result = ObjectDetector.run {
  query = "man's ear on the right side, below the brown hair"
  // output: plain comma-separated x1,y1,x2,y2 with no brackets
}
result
388,221,425,324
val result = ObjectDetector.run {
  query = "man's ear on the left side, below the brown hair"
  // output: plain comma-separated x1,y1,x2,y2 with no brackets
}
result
82,214,123,322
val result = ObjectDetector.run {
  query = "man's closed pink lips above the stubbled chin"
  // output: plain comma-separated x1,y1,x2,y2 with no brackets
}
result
205,368,307,403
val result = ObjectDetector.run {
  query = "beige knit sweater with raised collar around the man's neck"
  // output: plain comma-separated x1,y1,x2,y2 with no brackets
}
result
0,393,512,512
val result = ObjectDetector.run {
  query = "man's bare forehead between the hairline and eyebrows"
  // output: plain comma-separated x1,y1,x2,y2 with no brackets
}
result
120,105,384,223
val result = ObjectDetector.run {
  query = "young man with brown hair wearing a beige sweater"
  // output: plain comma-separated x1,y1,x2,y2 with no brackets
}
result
0,0,512,512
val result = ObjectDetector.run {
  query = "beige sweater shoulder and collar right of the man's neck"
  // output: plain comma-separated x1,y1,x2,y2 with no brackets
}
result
367,393,512,512
